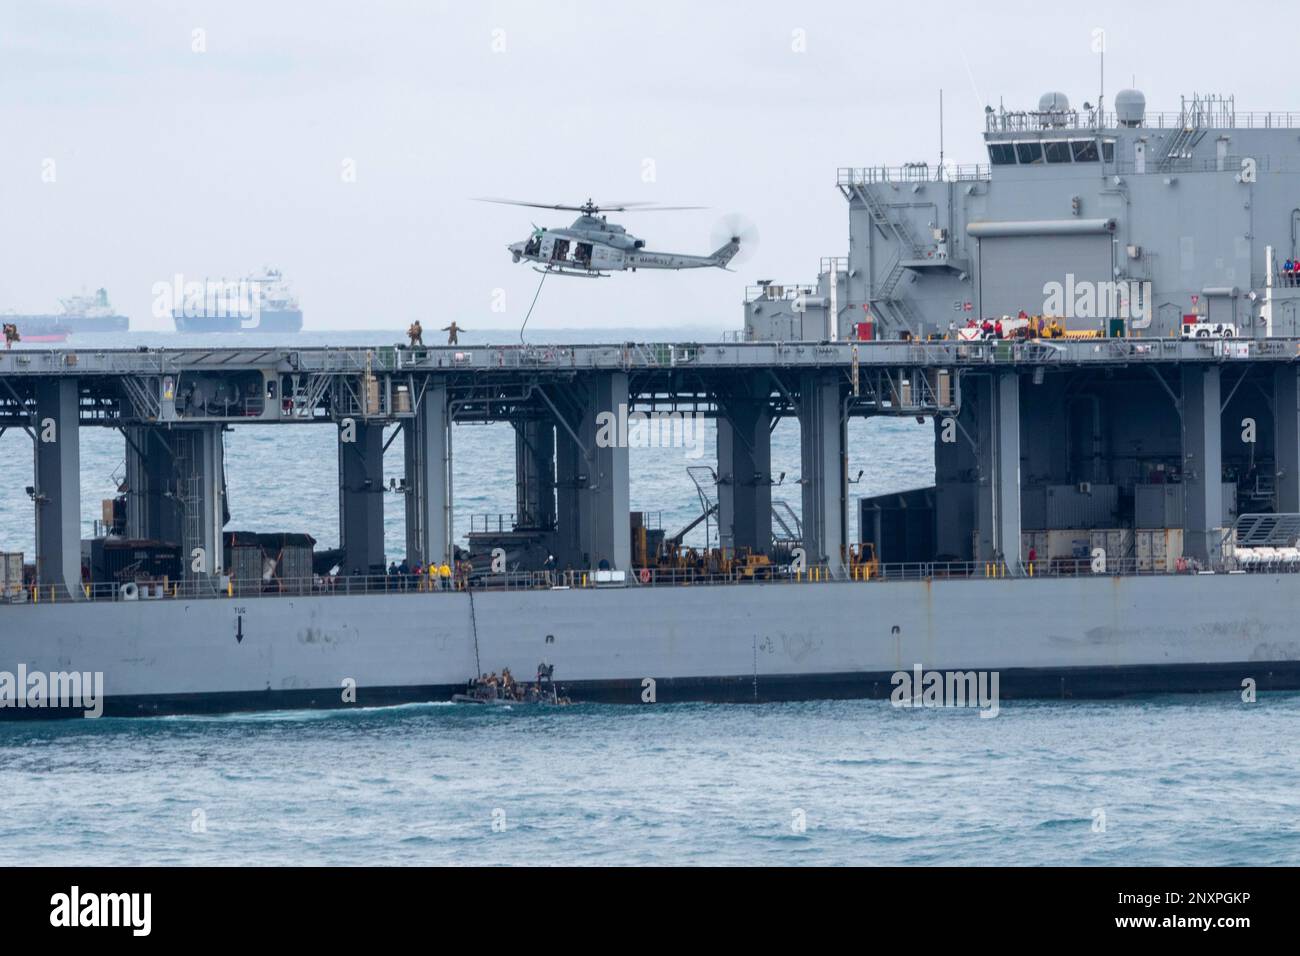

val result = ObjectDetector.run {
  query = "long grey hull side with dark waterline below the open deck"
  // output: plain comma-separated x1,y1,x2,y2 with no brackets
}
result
0,575,1300,718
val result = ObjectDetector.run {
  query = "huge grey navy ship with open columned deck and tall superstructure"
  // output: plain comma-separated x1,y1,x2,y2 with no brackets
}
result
0,90,1300,717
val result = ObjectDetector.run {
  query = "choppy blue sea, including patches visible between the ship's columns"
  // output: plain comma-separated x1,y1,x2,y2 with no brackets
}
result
0,329,1300,865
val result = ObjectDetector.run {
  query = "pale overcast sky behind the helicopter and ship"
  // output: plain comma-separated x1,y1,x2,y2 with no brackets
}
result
0,0,1284,329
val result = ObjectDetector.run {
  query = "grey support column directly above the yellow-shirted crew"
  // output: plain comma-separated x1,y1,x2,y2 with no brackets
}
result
403,385,452,567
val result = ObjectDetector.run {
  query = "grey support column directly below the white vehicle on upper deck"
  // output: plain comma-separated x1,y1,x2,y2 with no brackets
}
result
1183,365,1223,563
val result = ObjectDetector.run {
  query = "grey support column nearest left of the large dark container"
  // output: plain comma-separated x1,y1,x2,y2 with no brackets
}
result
798,373,848,574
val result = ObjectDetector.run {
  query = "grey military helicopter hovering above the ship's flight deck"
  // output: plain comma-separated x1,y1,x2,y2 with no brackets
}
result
478,199,745,278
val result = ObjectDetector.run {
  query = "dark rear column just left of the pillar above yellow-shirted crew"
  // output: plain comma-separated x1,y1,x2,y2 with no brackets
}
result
338,419,385,575
